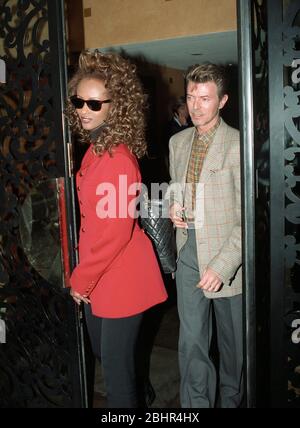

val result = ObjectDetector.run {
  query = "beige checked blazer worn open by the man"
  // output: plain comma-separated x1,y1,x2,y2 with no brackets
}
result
167,120,242,298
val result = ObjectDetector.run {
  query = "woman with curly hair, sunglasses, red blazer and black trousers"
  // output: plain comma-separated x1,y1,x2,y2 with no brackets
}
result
66,51,167,408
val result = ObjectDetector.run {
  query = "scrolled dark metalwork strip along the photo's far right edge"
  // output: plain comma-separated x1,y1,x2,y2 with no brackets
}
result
282,1,300,407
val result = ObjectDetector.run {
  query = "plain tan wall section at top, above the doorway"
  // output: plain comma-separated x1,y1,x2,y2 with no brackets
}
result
83,0,237,48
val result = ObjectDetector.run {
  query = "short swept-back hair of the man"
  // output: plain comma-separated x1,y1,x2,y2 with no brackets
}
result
185,63,228,99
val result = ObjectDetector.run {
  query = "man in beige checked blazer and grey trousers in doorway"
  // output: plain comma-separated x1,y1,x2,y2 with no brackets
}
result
168,64,243,408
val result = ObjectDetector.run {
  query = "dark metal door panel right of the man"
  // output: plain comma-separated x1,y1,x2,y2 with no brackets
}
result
239,0,300,407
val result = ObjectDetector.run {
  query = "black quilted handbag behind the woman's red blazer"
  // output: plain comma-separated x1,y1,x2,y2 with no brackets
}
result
140,199,176,273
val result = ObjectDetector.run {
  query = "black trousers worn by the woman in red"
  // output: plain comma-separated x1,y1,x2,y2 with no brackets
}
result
85,305,143,408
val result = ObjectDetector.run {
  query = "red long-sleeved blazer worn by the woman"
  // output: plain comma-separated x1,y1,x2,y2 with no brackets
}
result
70,144,167,318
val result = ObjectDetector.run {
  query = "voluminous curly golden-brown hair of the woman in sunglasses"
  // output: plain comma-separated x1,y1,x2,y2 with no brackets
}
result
65,50,147,158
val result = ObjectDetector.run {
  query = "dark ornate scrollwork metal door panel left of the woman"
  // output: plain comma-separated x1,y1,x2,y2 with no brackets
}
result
0,0,86,408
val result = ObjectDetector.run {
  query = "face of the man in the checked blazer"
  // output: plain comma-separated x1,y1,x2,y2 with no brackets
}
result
186,82,228,132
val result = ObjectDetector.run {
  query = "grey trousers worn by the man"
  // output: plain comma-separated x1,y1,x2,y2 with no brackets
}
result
176,230,243,408
